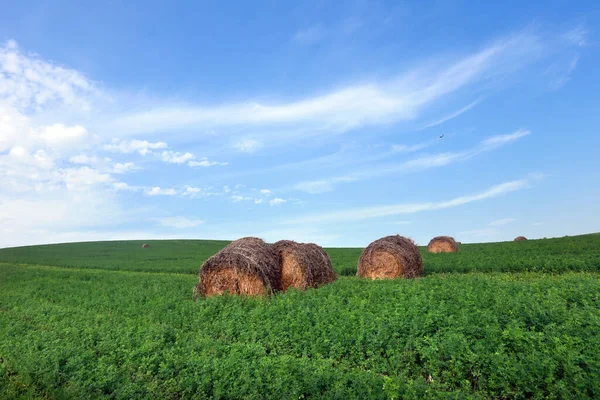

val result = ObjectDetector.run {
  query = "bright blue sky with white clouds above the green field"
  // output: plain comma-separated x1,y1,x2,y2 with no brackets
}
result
0,1,600,247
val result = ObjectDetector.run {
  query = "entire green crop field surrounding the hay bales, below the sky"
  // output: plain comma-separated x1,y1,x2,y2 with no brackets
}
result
0,234,600,399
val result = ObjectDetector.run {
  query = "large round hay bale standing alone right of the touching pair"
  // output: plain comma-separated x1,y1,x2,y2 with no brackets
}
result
356,235,423,279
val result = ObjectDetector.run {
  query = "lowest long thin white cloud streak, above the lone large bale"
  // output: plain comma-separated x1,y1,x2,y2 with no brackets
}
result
284,179,529,224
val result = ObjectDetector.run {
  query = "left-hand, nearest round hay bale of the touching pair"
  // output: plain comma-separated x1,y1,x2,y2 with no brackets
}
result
194,237,281,297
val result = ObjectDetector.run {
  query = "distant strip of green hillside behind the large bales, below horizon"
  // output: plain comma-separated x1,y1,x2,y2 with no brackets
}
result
0,234,600,275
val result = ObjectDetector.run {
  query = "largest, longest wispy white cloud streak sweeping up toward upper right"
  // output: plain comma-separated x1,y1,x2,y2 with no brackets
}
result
109,32,544,135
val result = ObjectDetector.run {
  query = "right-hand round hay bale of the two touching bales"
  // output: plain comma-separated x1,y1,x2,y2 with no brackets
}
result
273,240,337,291
